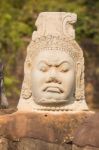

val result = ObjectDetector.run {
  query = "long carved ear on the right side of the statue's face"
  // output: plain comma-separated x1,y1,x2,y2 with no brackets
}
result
75,61,85,100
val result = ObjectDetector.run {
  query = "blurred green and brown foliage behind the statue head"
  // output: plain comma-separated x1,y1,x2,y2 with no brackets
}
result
0,0,99,103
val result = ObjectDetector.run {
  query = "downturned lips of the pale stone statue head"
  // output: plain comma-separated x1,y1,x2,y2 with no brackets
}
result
43,86,63,93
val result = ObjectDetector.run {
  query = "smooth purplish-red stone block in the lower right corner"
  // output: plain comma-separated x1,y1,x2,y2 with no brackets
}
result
73,112,99,148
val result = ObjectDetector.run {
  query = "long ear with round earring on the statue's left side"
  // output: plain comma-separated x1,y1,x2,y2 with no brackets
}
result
21,60,32,99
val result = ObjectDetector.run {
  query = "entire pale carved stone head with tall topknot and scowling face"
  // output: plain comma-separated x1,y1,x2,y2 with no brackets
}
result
18,12,88,111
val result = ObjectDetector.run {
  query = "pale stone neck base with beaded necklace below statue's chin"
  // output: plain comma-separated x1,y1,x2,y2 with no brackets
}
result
18,98,88,112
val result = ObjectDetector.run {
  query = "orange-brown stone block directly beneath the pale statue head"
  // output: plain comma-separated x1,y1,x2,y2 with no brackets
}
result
0,112,93,144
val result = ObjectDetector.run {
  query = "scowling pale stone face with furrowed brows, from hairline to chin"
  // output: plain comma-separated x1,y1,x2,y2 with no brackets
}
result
32,50,75,105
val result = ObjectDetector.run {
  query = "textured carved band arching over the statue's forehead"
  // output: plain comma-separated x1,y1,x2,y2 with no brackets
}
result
28,36,83,62
